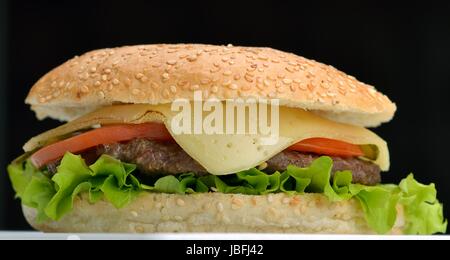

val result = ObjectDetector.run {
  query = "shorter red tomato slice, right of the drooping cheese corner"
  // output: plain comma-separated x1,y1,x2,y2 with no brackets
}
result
287,138,364,157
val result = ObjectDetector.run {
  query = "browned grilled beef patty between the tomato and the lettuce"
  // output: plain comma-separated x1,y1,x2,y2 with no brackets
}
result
96,138,381,185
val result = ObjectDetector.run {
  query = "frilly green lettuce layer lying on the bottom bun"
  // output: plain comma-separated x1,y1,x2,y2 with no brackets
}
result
8,153,447,234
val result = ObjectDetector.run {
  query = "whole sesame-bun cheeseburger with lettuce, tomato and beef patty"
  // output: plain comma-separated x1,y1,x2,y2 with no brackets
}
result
8,44,447,234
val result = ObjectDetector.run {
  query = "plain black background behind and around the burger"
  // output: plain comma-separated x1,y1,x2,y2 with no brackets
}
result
0,0,450,230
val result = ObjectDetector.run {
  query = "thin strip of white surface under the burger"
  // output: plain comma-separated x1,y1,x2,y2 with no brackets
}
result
0,231,450,240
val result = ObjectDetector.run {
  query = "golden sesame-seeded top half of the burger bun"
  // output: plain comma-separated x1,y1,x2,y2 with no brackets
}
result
26,44,396,127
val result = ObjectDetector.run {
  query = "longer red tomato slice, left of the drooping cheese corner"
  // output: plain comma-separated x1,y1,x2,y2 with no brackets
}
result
31,123,172,168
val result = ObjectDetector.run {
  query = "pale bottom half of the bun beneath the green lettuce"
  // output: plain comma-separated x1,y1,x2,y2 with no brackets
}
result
23,193,404,234
